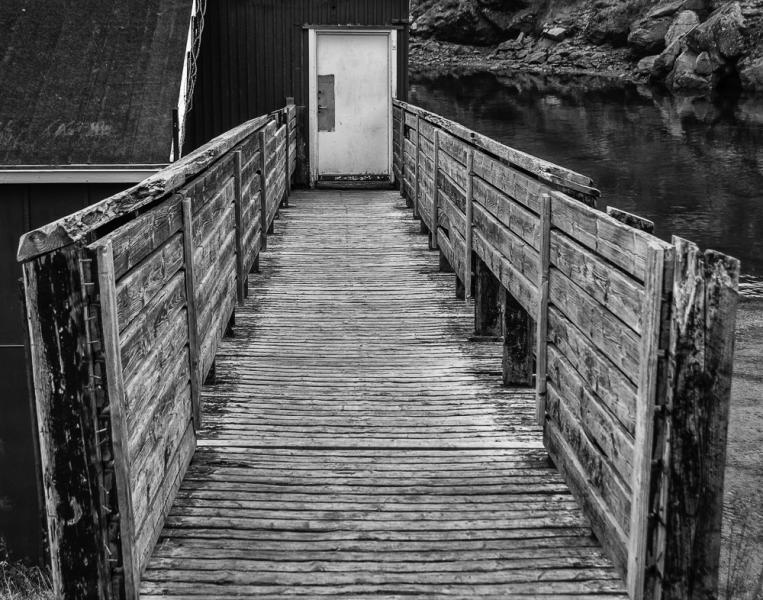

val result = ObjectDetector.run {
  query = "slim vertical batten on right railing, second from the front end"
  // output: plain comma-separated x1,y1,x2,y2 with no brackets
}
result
535,194,551,427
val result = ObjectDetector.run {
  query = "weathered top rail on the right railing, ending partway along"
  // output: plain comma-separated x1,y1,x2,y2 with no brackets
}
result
394,100,600,197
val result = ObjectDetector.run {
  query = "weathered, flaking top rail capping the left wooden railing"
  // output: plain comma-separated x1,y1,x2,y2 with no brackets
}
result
17,115,273,262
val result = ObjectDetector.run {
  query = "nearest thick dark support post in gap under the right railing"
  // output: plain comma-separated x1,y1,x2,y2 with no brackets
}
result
501,288,533,387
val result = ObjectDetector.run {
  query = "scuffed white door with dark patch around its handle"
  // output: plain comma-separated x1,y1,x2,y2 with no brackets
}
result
310,31,394,179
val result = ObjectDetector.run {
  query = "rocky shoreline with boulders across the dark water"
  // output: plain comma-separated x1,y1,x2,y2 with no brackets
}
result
410,0,763,95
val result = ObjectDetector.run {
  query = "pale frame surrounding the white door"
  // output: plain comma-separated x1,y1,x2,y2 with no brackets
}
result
307,27,398,187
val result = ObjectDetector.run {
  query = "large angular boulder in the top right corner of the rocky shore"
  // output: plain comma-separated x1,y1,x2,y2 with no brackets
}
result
685,2,748,59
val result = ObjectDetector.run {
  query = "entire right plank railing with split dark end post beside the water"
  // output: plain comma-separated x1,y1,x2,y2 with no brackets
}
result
393,102,739,598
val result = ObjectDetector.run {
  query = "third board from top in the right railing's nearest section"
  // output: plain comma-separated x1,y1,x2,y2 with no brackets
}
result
549,269,639,384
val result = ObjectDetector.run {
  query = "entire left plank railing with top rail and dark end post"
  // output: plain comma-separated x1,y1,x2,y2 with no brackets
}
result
18,104,297,598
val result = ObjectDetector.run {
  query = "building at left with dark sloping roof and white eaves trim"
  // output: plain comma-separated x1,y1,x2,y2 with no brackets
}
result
0,0,196,559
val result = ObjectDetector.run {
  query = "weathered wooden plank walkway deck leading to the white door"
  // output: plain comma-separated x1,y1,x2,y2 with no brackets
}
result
141,191,626,599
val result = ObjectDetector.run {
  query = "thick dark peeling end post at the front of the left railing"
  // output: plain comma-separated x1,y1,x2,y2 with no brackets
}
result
22,245,112,600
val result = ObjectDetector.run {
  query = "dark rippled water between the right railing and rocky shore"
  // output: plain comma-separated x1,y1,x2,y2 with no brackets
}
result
410,74,763,295
